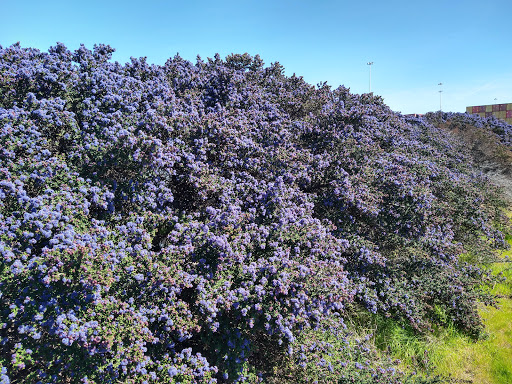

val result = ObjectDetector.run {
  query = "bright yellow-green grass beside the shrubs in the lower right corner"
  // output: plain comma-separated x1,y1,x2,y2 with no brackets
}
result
374,222,512,384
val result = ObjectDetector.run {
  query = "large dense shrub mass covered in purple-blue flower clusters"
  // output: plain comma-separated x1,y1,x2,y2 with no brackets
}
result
0,44,510,383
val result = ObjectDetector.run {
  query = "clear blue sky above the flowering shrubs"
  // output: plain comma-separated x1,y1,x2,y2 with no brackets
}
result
0,0,512,113
